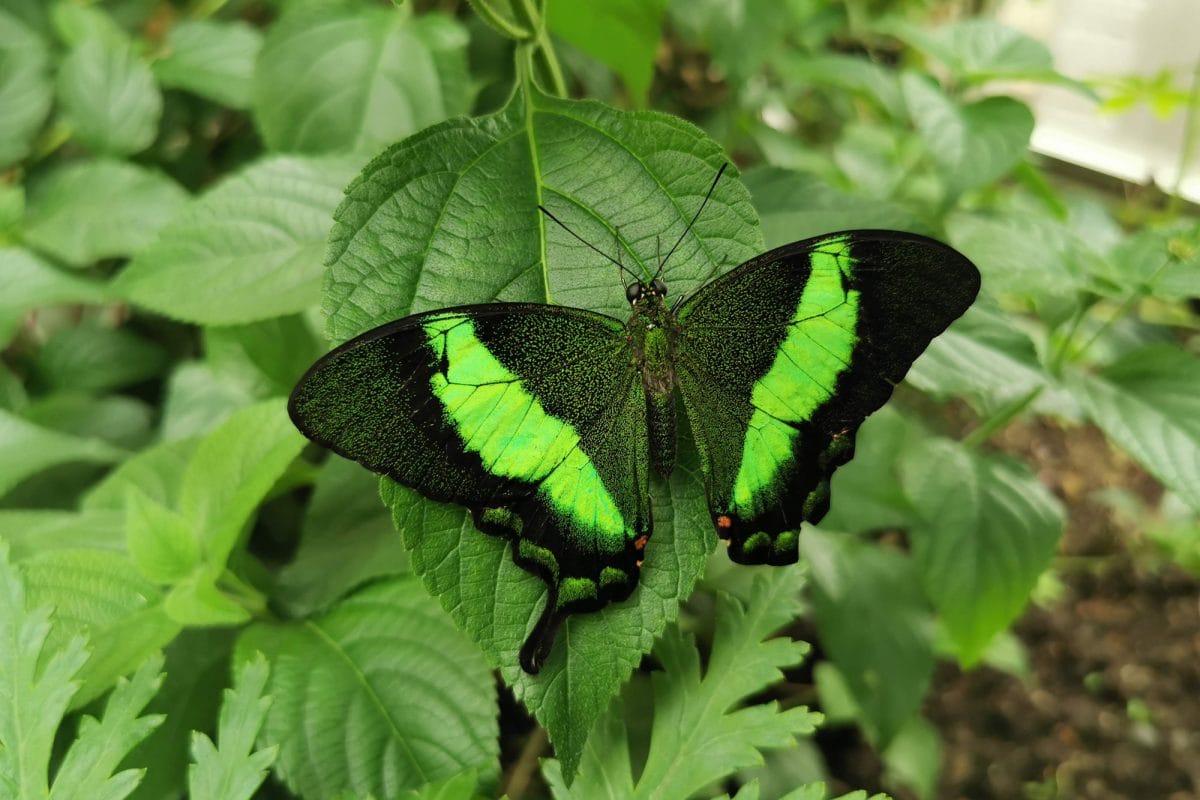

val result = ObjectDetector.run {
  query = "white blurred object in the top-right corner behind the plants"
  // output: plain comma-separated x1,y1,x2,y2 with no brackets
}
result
998,0,1200,201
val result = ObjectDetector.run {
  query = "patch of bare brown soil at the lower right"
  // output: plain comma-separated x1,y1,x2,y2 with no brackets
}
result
925,423,1200,800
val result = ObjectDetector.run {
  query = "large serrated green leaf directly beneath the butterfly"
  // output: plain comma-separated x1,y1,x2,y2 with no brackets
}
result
325,92,762,775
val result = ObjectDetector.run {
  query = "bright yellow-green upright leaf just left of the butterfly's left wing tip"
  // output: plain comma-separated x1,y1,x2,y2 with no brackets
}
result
179,399,305,572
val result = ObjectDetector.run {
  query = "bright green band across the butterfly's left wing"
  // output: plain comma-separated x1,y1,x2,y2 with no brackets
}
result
425,317,634,552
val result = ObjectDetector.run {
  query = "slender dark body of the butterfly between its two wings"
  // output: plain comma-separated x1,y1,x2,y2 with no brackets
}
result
626,283,676,477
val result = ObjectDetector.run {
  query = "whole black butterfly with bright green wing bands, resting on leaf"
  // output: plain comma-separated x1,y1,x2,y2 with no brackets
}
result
288,173,979,673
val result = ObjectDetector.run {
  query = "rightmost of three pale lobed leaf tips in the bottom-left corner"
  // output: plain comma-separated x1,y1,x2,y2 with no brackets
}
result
187,652,278,800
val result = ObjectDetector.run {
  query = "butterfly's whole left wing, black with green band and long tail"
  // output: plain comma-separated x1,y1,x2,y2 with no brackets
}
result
290,303,650,672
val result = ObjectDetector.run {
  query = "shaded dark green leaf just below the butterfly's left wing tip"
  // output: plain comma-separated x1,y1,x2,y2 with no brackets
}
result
272,455,409,615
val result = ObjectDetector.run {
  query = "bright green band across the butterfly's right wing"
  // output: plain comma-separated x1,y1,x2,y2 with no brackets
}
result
733,239,859,516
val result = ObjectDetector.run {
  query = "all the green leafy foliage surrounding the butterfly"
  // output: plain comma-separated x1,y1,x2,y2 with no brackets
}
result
0,0,1200,800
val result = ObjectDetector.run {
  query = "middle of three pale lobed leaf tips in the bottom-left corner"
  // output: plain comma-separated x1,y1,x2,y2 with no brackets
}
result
49,655,162,800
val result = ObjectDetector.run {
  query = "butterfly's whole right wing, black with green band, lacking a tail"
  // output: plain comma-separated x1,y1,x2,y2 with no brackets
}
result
674,230,979,564
